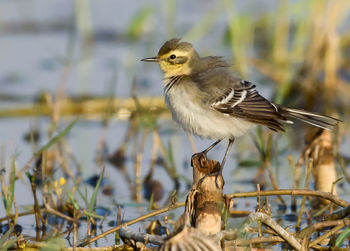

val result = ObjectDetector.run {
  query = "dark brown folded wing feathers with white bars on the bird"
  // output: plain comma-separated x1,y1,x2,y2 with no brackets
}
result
210,80,287,131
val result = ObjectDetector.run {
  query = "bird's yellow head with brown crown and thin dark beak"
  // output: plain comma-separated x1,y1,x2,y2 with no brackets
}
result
141,38,200,78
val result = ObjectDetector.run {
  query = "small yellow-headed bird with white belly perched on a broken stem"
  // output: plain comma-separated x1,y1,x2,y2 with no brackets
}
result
141,38,340,170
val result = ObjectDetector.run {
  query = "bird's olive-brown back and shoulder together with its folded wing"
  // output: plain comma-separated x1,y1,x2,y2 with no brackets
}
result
192,63,287,131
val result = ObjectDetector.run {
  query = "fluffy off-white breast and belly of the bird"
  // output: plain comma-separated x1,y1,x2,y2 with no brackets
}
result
165,85,252,140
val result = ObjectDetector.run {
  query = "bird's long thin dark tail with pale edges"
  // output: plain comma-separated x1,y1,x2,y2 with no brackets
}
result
279,107,341,130
